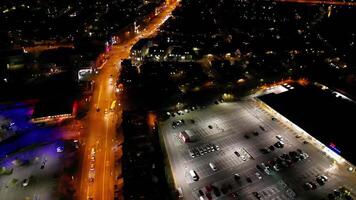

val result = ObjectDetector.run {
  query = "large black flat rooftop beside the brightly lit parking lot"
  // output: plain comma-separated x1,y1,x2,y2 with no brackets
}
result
259,82,356,164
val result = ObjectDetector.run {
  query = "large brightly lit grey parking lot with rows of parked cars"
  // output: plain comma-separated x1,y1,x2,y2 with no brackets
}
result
159,99,356,200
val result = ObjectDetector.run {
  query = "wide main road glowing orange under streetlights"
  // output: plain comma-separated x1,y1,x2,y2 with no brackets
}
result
77,0,179,200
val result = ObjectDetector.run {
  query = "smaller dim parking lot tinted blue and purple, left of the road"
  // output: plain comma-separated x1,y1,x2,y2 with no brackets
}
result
0,144,62,200
